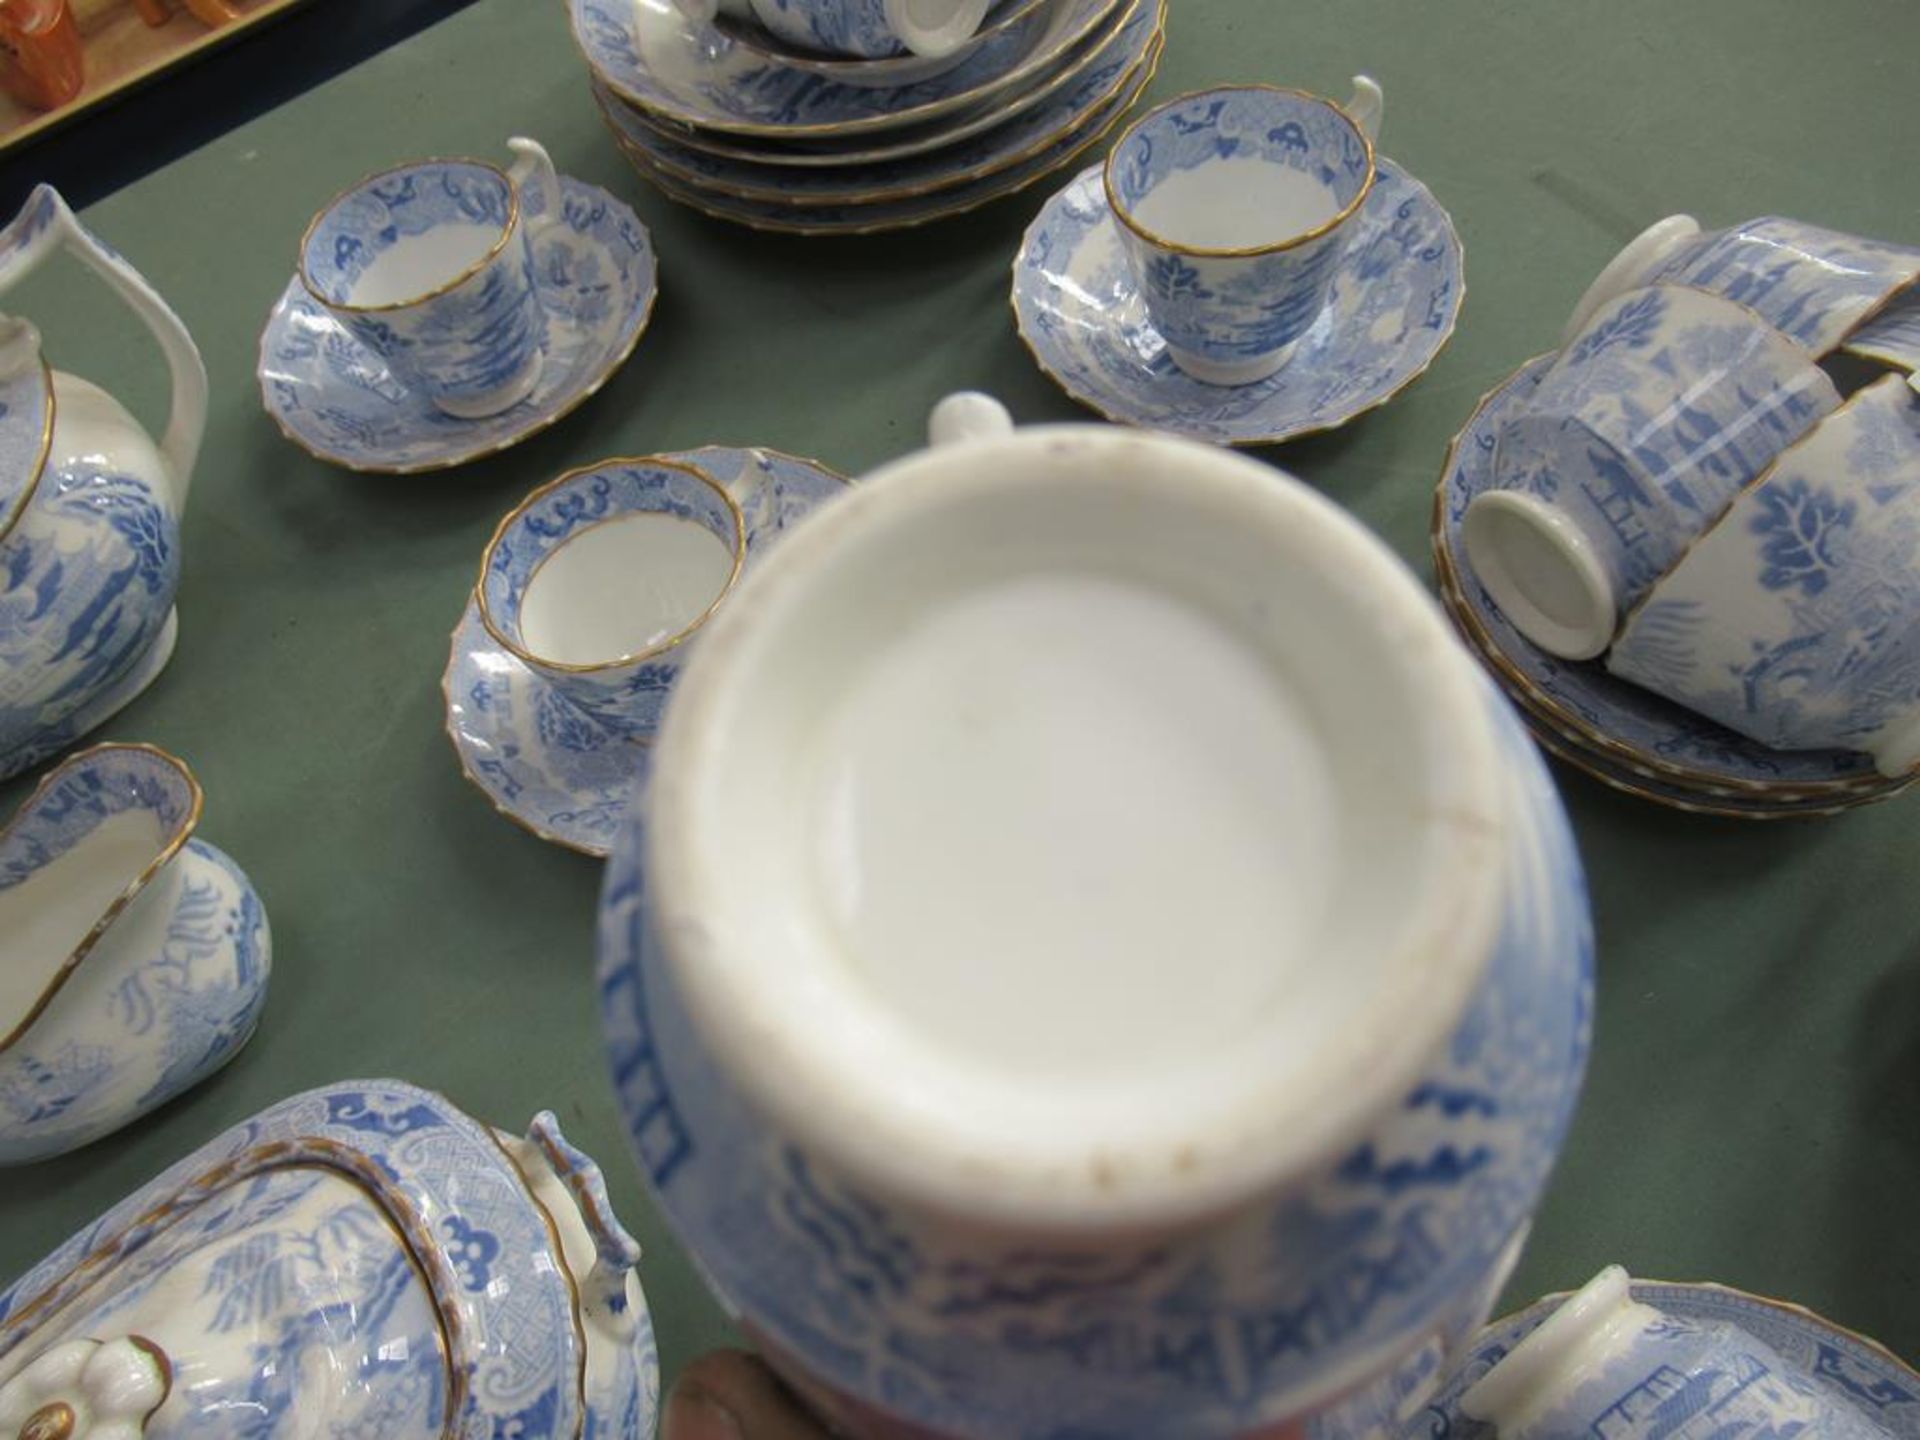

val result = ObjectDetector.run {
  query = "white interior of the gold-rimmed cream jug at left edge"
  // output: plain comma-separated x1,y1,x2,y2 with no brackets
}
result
0,810,169,1035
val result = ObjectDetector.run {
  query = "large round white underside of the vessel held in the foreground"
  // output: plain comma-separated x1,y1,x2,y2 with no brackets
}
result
649,410,1507,1225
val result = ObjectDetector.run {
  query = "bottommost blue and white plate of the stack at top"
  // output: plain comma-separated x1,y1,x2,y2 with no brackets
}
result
622,31,1165,234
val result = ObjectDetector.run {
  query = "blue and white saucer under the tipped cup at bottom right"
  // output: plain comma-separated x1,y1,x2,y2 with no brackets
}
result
1402,1281,1920,1440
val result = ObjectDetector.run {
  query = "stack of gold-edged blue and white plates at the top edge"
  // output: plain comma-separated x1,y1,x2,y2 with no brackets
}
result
568,0,1165,234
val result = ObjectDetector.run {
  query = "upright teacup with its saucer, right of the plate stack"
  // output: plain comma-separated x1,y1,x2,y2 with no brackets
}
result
1014,77,1465,445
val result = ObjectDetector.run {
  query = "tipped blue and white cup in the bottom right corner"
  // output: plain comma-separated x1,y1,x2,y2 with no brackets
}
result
1459,1265,1887,1440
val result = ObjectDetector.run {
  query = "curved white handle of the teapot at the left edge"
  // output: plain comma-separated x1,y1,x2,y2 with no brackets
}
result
0,184,207,509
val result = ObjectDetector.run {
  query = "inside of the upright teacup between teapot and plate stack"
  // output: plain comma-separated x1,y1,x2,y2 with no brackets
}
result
300,159,518,311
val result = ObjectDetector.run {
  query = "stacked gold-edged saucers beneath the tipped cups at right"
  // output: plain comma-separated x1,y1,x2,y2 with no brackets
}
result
1432,355,1907,816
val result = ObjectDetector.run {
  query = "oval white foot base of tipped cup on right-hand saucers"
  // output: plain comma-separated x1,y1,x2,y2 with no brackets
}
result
1461,490,1619,660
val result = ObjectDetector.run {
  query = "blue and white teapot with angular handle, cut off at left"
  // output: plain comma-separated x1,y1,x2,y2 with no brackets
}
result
0,184,207,780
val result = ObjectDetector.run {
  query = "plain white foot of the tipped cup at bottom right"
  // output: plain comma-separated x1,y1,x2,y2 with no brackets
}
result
1459,1265,1661,1436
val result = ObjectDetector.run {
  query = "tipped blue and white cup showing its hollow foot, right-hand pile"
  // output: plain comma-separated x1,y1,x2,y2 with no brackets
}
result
1461,286,1839,660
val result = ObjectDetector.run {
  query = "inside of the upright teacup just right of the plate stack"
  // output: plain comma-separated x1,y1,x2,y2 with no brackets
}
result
1106,86,1373,253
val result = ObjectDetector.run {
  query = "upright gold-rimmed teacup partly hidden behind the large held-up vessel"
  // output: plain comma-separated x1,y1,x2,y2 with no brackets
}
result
476,459,747,739
